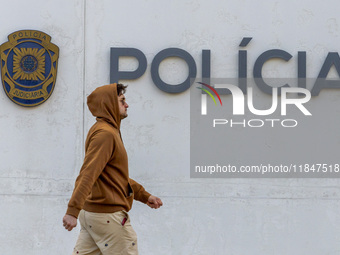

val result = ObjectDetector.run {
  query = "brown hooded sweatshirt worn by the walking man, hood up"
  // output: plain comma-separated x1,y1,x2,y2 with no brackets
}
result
66,84,150,218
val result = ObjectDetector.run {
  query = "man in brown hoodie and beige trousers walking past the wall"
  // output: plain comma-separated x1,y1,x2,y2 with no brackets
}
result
63,83,163,255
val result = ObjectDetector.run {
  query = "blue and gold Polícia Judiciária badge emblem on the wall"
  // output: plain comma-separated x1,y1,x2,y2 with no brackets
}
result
0,30,59,106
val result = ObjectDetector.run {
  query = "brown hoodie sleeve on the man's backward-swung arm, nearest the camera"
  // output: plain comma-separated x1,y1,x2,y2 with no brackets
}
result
66,130,114,218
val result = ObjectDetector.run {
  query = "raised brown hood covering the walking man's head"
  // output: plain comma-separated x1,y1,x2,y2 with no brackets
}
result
87,83,121,129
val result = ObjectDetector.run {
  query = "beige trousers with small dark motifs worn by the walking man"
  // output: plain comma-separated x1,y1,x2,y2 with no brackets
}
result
72,210,138,255
